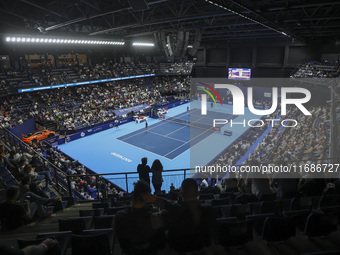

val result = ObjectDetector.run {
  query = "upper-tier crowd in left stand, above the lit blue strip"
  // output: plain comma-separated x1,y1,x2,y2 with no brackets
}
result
0,61,193,93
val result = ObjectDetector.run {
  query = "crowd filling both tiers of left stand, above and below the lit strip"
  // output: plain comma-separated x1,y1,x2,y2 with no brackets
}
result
0,62,192,130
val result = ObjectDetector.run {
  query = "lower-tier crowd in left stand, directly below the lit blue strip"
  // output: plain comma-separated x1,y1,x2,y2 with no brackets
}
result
0,76,190,130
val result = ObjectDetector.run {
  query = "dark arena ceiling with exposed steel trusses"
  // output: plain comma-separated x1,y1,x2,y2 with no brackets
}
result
0,0,340,44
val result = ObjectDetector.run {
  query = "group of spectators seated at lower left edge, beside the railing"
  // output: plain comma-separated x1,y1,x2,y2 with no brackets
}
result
0,138,59,230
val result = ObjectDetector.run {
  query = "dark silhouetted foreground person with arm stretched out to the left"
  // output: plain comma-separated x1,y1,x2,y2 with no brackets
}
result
143,178,215,252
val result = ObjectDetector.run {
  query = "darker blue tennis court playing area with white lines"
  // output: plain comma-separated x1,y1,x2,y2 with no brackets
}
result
117,108,238,159
